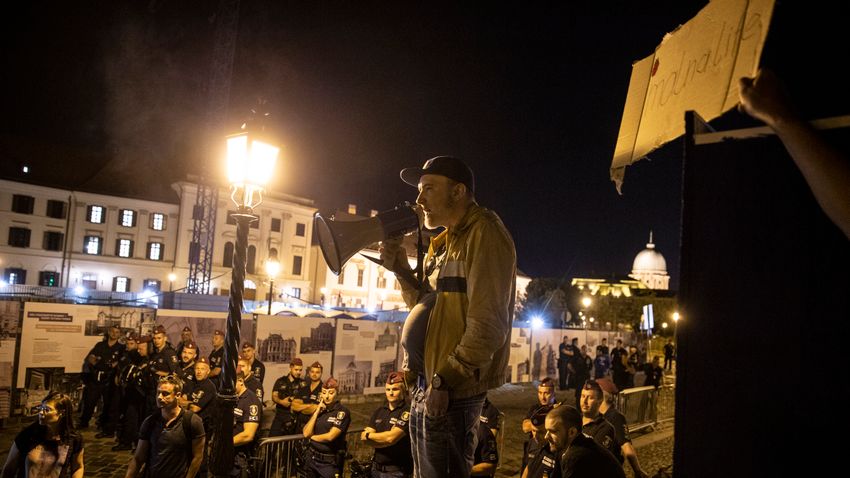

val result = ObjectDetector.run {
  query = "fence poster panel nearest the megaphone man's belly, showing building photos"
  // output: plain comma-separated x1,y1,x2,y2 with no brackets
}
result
333,319,399,395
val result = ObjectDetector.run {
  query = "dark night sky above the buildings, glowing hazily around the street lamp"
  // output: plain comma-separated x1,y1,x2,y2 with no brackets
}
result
0,0,847,287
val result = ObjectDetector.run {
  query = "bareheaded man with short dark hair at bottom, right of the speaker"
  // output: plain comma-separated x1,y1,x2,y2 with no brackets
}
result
545,405,626,478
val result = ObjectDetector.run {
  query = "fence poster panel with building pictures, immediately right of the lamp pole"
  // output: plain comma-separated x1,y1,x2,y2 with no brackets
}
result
256,315,336,399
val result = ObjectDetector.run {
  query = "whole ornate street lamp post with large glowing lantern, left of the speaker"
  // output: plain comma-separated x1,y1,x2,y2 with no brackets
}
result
209,126,279,476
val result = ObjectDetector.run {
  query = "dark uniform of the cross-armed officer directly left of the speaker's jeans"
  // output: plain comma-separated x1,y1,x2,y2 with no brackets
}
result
369,401,413,478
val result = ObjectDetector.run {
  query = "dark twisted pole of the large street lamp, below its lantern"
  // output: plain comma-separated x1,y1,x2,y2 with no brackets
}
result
209,206,257,477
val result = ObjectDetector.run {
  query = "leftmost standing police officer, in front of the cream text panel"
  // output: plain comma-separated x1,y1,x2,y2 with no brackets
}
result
77,324,124,430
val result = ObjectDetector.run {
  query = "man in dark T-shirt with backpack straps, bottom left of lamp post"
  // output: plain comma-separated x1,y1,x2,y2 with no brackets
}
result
126,376,205,478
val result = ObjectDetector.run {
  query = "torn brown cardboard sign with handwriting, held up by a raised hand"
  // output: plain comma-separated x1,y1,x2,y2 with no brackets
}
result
611,0,774,191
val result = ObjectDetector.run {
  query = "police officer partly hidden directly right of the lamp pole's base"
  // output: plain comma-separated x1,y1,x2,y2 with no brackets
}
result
230,370,262,476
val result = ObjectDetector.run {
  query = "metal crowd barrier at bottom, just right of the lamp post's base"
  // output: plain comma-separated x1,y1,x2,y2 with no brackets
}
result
253,428,364,478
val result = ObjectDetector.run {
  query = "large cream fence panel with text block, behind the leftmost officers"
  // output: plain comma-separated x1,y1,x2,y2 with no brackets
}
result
17,302,154,391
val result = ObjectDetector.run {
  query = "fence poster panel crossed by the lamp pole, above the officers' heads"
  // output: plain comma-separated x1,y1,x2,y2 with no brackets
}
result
155,309,255,360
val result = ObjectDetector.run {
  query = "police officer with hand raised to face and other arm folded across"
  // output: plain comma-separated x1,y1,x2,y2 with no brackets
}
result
304,377,351,478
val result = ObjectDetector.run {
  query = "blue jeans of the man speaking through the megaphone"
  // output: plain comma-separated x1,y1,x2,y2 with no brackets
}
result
410,387,487,478
